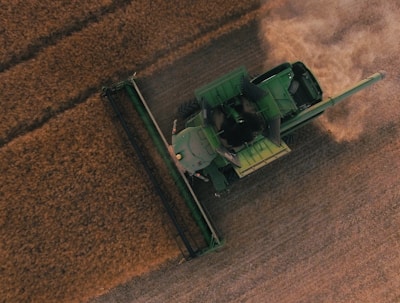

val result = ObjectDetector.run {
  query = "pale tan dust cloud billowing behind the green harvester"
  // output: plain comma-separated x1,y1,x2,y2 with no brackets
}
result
260,0,400,141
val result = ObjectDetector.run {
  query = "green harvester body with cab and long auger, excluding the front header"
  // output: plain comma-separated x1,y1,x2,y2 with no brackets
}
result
172,62,384,192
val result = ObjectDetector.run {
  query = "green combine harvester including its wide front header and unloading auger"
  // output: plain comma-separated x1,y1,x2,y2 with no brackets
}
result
103,62,385,257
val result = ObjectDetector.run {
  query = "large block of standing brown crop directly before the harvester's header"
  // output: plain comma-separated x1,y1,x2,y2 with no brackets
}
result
0,97,180,302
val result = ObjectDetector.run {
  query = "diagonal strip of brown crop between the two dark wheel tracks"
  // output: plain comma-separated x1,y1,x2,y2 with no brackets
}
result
0,0,259,145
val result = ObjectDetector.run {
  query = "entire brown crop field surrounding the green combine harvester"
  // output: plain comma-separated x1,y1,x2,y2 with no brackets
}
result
0,0,400,303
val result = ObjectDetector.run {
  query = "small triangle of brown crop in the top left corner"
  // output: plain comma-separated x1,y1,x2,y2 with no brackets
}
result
0,0,117,66
